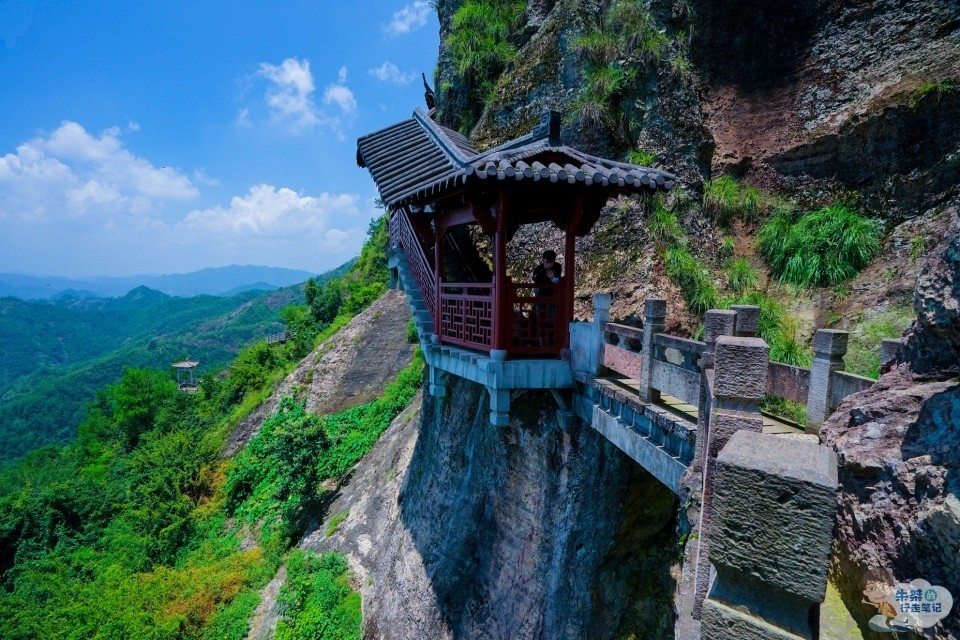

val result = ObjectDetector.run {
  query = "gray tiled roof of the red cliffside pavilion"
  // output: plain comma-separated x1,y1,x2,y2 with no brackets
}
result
357,109,676,208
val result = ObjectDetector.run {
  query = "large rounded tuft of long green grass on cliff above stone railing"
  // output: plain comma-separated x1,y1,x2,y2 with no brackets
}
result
757,205,881,287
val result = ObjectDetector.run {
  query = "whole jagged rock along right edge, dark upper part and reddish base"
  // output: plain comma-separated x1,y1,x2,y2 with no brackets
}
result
821,212,960,638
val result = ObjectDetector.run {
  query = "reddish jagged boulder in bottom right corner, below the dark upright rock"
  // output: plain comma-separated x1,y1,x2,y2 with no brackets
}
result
820,366,960,638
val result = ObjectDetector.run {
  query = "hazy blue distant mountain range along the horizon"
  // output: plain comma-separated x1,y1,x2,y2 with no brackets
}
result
0,265,317,300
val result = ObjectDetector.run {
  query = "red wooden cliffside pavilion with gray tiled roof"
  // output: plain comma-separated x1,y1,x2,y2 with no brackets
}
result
357,109,676,360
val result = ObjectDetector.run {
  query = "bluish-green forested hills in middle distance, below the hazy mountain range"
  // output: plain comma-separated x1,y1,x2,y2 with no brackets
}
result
0,263,351,460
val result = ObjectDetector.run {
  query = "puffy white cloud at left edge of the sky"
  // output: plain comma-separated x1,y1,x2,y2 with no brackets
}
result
0,121,199,221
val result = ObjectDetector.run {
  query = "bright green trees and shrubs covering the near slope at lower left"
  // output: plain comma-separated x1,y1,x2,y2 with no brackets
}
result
0,214,414,640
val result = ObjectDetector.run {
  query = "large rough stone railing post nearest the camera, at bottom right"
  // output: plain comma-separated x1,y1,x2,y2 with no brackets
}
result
701,431,837,640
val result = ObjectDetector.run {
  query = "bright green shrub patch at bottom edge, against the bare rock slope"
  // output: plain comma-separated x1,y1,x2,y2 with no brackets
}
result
274,550,362,640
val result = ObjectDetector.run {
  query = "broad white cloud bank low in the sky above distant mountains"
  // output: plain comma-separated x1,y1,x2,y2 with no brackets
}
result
0,124,375,275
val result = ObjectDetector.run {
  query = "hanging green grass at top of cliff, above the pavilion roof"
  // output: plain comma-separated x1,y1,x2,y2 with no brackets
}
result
446,0,527,134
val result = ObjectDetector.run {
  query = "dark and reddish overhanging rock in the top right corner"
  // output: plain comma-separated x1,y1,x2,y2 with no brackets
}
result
693,0,960,218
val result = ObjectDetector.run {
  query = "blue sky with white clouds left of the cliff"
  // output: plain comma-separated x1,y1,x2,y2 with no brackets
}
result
0,0,439,276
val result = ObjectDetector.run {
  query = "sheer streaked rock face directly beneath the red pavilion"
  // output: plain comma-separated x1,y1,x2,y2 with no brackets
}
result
305,380,677,639
